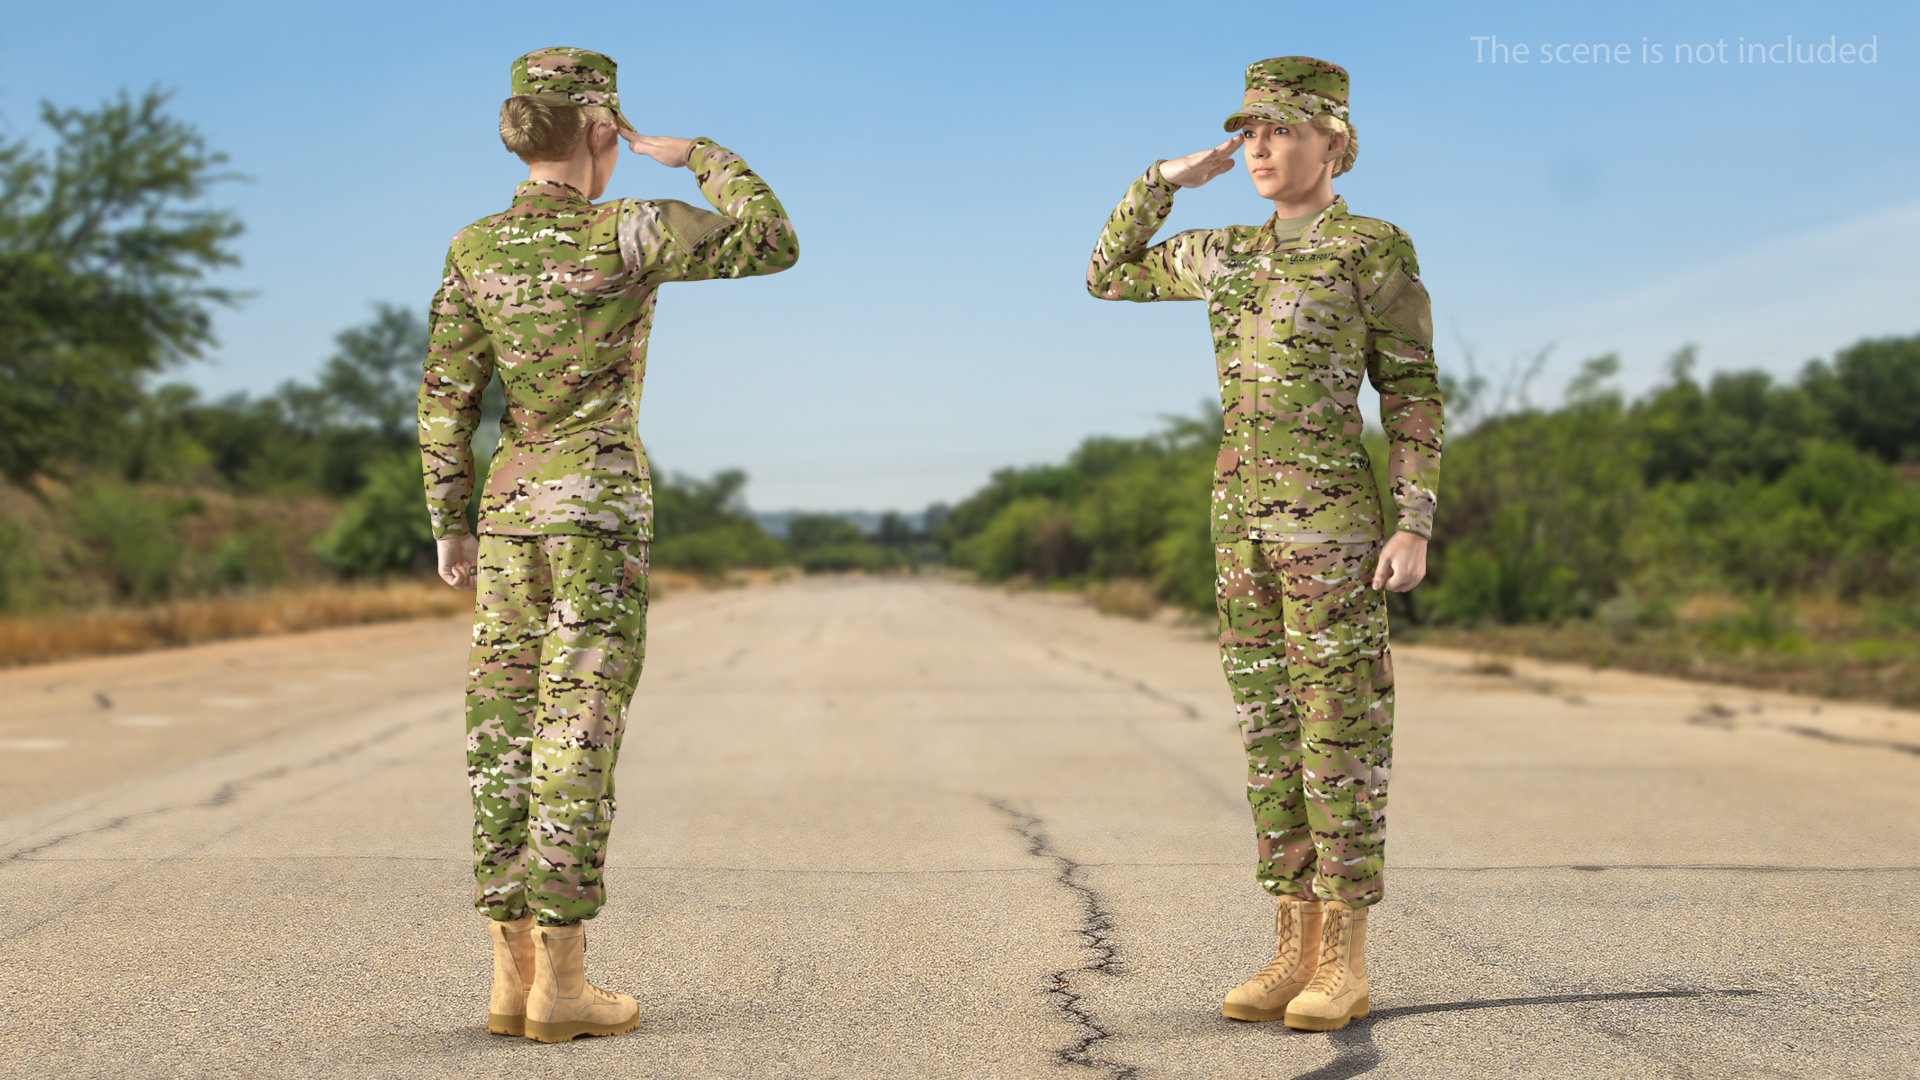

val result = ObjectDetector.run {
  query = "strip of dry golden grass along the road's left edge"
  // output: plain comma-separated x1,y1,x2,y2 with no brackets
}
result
0,580,472,667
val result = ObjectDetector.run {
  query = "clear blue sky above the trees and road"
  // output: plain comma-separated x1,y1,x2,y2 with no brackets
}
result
0,0,1920,509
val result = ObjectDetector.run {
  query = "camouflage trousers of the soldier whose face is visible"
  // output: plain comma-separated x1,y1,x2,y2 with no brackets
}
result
1213,542,1394,907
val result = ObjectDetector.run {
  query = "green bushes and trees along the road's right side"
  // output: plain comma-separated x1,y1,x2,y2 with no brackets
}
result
939,336,1920,703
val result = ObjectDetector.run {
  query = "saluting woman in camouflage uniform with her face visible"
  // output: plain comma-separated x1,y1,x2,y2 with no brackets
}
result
1087,56,1442,1030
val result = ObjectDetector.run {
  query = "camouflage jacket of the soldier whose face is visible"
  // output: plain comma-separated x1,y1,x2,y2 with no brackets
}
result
1087,163,1442,544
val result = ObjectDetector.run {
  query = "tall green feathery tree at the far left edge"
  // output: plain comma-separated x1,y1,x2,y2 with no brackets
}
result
0,90,240,482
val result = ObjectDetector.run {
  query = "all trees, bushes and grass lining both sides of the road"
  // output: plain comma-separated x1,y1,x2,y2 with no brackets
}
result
18,92,1920,703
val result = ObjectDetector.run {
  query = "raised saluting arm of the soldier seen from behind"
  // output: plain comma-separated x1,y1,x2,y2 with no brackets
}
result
618,131,801,282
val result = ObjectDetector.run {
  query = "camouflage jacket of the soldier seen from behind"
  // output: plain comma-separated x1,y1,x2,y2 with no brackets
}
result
419,138,801,540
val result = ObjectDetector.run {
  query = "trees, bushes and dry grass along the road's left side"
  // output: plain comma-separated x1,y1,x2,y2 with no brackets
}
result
0,84,937,663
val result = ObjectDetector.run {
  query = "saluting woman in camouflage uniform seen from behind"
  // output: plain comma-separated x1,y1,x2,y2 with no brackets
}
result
419,48,799,1042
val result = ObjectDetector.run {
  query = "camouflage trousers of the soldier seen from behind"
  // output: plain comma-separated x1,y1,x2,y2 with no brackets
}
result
467,536,647,914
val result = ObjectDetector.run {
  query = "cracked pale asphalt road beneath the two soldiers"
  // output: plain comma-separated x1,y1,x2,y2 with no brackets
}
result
0,578,1920,1080
